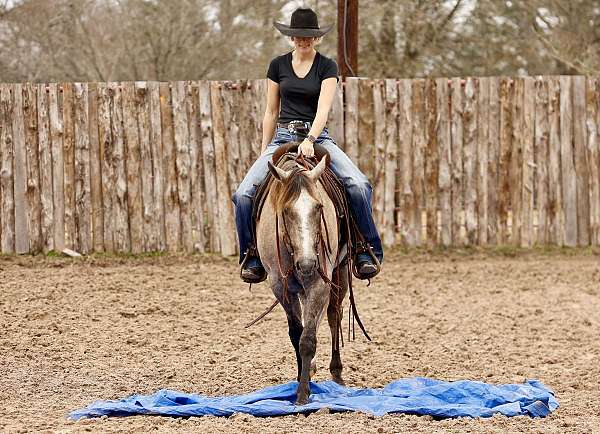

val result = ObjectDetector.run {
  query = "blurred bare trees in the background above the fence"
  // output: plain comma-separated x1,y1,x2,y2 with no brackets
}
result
0,0,600,82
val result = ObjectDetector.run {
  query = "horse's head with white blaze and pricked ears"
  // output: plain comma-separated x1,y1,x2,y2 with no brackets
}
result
269,157,326,278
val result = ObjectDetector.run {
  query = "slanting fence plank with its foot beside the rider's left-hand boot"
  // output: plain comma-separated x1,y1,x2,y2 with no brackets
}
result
210,81,237,256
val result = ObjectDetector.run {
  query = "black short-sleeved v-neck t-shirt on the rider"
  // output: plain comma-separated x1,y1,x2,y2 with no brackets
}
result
267,51,339,123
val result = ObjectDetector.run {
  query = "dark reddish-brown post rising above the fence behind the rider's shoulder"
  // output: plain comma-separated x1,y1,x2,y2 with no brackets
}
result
338,0,358,78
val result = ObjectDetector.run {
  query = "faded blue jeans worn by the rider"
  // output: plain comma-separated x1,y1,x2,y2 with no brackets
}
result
232,128,383,262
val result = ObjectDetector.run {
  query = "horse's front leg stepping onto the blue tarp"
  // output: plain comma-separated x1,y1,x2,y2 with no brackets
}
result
296,281,329,405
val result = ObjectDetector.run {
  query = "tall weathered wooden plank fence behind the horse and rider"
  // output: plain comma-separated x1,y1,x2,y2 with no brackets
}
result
0,76,600,255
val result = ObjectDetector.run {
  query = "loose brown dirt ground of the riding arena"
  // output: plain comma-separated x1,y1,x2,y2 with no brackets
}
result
0,251,600,434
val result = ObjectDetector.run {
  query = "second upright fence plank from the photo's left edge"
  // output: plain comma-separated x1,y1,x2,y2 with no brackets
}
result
10,84,29,254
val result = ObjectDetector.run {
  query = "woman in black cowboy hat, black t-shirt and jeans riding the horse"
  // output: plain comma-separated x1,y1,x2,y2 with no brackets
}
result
233,8,383,283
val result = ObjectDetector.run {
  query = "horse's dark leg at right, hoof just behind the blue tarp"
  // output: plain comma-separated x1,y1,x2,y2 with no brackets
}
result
327,266,348,385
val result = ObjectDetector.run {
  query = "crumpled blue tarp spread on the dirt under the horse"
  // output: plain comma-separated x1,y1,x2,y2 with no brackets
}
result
69,377,558,420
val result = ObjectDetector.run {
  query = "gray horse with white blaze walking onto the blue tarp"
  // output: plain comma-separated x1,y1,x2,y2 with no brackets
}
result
256,157,348,405
